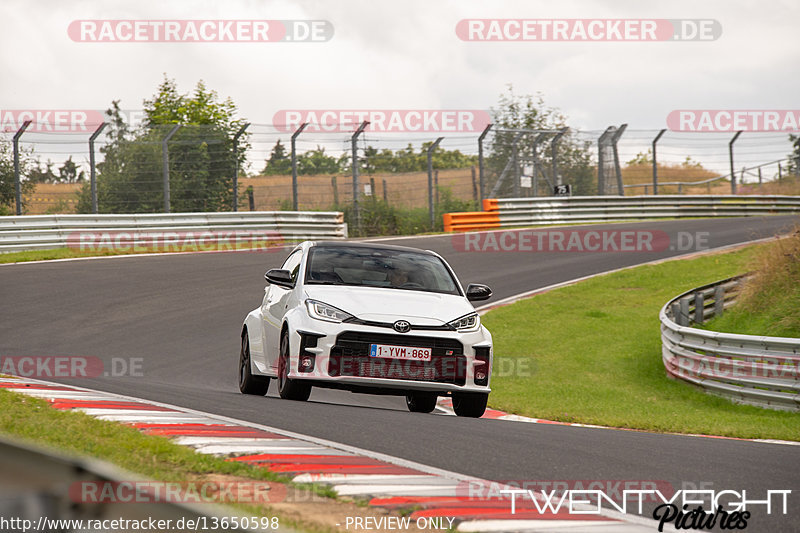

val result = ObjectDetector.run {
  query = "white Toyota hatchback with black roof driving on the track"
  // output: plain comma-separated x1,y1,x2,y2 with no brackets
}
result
239,241,492,417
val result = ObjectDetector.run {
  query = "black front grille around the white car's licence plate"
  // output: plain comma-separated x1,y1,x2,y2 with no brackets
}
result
328,331,467,385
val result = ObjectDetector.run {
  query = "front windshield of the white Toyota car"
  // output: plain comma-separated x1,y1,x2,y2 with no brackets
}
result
306,246,461,294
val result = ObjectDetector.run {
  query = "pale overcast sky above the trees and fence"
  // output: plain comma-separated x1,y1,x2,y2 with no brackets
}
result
0,0,800,172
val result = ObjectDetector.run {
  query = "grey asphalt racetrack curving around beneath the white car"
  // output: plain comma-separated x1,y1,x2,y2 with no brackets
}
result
0,216,800,531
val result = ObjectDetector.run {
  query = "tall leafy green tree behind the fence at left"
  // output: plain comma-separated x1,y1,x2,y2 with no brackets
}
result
78,76,249,212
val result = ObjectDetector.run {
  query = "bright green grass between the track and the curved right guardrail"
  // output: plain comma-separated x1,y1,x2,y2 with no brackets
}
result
483,243,800,440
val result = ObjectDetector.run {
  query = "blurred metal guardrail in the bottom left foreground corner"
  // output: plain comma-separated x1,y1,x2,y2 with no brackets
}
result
0,438,284,533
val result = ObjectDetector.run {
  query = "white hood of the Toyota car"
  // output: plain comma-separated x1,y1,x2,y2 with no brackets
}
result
304,285,475,326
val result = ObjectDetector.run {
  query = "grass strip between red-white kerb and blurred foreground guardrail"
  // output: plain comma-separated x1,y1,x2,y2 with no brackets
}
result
0,389,336,531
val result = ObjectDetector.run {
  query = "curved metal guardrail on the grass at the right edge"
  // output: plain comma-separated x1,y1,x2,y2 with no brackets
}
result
659,276,800,411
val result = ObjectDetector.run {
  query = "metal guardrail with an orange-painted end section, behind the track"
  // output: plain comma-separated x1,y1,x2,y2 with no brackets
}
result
445,195,800,231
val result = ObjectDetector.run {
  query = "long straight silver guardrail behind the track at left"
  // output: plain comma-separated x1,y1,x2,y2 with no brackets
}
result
0,211,347,252
